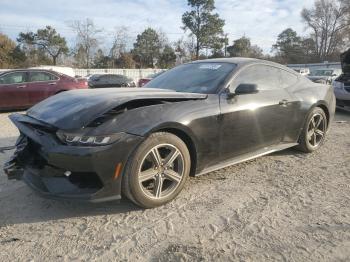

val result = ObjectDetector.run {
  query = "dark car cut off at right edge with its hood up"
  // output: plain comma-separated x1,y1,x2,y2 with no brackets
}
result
333,49,350,109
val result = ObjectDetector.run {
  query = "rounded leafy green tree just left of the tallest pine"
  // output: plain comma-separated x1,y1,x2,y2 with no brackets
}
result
132,28,162,68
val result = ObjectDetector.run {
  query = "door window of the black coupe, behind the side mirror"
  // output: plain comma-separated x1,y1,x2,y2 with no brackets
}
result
233,65,281,90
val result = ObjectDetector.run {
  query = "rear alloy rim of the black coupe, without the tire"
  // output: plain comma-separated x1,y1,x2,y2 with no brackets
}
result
307,113,326,147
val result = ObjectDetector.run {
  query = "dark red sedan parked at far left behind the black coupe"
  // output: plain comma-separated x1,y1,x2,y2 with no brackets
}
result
0,69,88,110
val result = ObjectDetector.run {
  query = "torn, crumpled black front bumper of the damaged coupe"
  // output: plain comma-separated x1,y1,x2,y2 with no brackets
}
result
4,114,143,202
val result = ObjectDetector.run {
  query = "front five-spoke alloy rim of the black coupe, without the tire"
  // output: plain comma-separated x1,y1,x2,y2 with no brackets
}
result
138,144,185,199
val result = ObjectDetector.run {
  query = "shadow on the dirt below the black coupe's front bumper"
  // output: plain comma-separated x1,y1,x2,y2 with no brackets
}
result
0,185,142,228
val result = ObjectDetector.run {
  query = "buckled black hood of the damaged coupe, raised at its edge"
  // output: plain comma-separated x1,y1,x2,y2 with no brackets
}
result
27,88,207,130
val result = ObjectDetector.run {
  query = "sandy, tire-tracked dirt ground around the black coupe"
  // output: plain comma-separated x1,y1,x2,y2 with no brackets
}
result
0,109,350,261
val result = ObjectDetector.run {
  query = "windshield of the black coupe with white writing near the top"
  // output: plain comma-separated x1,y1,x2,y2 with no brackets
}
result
145,62,237,94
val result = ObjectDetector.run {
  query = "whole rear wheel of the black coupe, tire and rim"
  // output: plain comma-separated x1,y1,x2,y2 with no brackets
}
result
296,107,327,153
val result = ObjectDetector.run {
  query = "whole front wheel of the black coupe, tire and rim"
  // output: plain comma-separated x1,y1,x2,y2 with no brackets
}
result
122,132,191,208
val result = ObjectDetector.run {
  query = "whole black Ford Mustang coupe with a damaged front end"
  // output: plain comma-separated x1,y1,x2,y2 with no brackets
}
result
5,58,335,208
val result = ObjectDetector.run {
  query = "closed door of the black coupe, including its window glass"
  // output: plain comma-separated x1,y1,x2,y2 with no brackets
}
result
220,65,293,160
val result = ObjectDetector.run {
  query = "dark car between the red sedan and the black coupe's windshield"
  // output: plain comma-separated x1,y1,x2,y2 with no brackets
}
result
88,74,136,88
